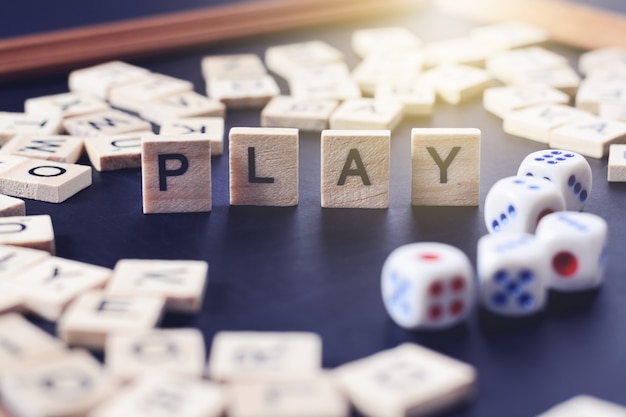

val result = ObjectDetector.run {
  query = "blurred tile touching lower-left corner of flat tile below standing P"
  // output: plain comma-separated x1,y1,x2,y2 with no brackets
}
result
57,291,165,349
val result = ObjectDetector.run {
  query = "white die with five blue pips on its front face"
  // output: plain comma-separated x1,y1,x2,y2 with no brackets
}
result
477,233,550,316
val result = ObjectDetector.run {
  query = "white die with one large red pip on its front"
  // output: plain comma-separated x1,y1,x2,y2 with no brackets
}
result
536,211,608,291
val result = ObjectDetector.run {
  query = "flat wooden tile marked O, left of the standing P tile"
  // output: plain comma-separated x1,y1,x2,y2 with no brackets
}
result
0,158,91,203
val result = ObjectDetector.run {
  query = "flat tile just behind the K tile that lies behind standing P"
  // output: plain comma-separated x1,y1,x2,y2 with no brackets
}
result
139,91,226,125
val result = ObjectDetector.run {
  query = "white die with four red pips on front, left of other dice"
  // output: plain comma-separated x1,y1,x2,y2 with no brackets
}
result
381,242,475,329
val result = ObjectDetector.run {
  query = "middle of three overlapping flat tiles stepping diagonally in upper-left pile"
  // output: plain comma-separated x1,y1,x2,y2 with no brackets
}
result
108,73,193,113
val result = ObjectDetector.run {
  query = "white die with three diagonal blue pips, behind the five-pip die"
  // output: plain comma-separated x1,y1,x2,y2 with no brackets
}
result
484,176,565,234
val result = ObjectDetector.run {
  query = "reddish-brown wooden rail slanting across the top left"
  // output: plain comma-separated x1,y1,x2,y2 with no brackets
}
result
0,0,421,81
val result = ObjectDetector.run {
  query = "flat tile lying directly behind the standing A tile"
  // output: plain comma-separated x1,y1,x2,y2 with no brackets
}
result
330,98,403,130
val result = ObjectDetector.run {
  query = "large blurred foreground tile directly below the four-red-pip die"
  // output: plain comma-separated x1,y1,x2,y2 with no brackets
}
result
335,343,476,417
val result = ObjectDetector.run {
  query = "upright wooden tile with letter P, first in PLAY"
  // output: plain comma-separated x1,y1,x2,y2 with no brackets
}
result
141,134,212,214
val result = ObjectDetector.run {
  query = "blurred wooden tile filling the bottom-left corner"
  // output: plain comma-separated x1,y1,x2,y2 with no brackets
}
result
0,351,114,417
